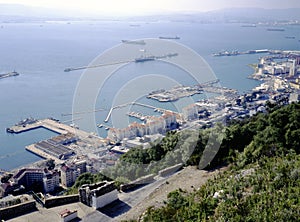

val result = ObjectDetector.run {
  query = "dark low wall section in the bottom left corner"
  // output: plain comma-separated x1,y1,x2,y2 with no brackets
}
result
0,200,36,220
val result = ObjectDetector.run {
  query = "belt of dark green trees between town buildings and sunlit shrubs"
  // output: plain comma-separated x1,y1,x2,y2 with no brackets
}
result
105,104,300,180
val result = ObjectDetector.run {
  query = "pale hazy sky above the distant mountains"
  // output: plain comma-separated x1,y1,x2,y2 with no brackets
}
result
0,0,300,14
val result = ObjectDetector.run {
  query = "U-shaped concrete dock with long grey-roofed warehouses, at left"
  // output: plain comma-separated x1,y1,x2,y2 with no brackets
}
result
7,118,106,163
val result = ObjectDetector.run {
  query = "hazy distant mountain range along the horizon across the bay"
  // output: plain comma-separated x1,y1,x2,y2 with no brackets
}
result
0,4,300,23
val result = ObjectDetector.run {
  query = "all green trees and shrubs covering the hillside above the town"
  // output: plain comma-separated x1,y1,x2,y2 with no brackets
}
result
69,104,300,221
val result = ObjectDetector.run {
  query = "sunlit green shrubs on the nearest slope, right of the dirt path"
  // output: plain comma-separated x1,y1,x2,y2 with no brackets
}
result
142,152,300,221
